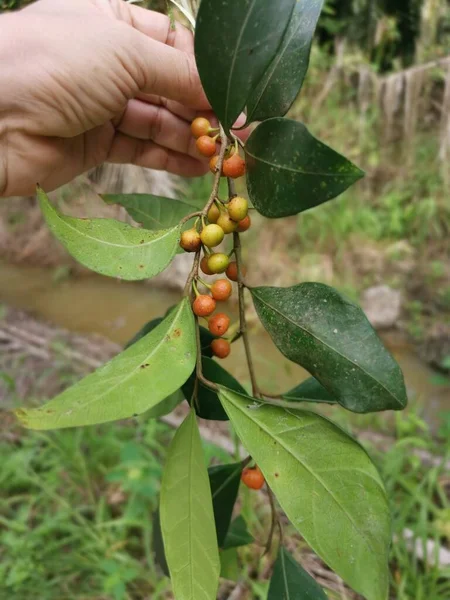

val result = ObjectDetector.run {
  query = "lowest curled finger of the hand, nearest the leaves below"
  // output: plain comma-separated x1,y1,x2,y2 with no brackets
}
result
106,133,208,177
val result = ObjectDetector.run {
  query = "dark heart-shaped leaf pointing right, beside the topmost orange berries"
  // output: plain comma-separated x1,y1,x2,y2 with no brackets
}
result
245,118,364,218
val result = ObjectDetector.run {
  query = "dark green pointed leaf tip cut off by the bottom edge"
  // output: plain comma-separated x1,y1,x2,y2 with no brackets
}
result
267,547,327,600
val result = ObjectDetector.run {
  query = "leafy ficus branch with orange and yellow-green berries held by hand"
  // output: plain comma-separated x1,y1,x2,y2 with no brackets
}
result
17,0,407,600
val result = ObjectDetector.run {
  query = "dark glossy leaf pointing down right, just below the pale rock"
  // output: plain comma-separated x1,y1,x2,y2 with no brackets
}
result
250,283,407,413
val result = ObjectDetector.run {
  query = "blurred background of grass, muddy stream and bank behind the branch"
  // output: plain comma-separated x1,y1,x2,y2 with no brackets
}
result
0,0,450,600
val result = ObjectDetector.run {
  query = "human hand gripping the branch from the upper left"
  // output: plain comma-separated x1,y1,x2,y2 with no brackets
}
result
0,0,212,196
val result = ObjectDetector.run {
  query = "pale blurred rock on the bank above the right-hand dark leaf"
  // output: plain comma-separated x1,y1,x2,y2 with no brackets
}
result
362,285,402,329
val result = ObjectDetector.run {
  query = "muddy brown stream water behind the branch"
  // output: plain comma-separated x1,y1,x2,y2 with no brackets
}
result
0,263,450,424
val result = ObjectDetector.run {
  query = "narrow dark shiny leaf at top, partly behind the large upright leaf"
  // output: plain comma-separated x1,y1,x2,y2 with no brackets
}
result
247,0,323,123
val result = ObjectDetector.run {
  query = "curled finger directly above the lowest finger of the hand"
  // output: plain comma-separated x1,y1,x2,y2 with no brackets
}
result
116,100,199,159
